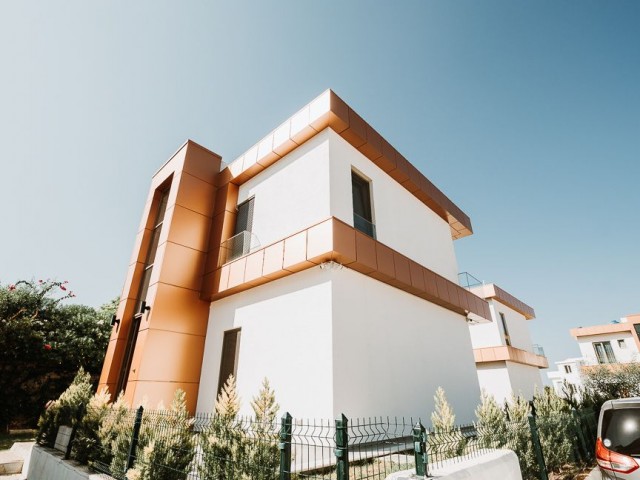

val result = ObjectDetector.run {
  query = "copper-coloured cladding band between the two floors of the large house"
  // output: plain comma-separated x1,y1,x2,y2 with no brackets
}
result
202,217,491,320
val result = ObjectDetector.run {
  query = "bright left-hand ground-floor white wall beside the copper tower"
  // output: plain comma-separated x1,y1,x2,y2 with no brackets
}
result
197,267,333,418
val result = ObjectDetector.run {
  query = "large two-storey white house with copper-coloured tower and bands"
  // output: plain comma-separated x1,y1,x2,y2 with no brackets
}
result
100,90,492,422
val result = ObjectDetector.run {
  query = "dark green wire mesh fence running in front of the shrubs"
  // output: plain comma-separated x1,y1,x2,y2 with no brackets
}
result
37,402,596,480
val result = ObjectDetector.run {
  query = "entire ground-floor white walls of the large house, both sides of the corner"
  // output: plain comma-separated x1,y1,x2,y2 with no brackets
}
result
197,267,480,423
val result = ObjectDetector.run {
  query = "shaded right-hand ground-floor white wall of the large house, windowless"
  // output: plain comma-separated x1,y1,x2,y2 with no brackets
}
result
331,268,480,423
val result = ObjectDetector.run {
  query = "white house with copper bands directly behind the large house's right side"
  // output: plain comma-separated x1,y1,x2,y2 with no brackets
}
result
461,273,549,403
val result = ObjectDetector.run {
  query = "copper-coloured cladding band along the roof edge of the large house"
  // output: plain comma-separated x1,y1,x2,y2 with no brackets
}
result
217,90,473,239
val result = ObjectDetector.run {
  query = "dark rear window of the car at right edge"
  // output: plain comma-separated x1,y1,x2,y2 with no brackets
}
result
602,408,640,456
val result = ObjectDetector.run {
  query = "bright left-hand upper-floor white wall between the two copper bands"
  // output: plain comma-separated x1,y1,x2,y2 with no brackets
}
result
238,130,332,246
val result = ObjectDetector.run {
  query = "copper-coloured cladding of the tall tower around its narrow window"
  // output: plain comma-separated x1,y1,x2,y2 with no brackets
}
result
100,141,222,412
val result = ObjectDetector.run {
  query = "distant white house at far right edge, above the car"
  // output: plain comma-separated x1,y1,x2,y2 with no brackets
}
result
571,314,640,366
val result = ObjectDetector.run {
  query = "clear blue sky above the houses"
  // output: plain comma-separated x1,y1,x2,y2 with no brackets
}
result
0,0,640,370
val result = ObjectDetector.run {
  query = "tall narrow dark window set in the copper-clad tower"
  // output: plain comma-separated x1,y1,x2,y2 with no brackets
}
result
116,187,169,393
